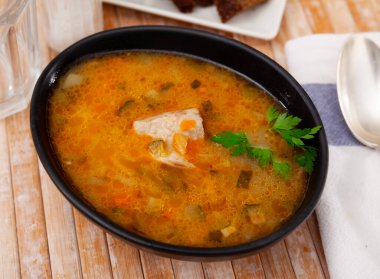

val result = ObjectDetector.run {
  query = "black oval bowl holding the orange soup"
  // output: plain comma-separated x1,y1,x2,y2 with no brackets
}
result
30,26,328,261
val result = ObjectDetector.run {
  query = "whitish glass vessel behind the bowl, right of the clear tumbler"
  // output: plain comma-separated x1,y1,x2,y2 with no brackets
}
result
44,0,103,51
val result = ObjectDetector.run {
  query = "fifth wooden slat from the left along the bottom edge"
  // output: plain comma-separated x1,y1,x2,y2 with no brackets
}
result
107,234,144,279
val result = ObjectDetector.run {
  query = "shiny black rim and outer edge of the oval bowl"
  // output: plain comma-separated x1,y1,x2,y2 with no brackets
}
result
30,25,328,260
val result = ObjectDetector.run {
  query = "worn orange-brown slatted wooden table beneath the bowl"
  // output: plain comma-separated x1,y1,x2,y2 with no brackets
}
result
0,0,380,279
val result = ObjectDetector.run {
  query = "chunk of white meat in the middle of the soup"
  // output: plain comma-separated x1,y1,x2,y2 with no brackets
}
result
133,108,204,168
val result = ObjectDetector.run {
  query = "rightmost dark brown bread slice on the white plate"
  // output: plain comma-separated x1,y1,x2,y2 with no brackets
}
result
215,0,267,22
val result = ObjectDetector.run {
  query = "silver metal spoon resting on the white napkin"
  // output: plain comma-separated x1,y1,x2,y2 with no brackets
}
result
337,36,380,149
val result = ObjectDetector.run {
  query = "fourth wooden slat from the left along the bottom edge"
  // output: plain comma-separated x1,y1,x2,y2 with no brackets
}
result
74,212,113,279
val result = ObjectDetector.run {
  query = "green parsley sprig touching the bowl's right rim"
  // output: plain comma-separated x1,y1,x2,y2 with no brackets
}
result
267,107,321,174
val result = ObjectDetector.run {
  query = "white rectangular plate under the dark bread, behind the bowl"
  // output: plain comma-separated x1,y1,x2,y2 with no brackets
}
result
103,0,286,40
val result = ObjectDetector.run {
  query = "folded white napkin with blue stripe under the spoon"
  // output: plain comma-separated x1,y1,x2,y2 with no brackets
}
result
285,33,380,279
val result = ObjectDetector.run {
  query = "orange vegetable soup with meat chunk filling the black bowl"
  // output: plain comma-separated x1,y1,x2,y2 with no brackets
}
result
49,51,308,247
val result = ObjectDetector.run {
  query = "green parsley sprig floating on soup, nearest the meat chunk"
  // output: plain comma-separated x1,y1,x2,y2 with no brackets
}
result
211,131,291,177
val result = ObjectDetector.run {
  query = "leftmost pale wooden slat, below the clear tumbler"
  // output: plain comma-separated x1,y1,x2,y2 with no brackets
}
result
0,120,20,279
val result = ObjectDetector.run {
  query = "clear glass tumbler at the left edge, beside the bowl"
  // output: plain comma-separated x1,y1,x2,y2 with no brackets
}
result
0,0,40,119
